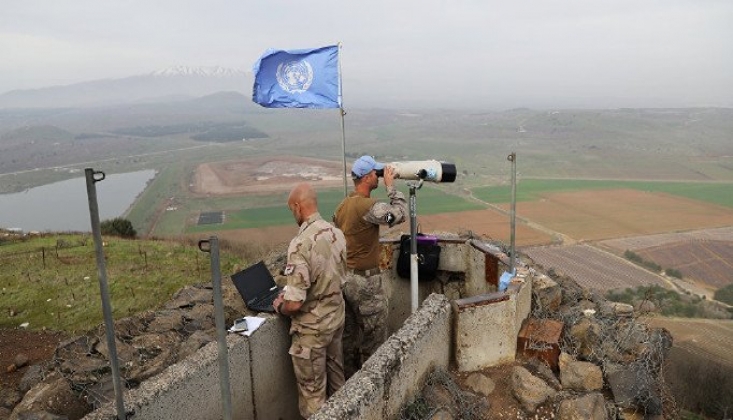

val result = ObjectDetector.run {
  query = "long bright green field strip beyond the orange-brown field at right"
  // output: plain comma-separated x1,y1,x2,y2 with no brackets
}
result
472,179,733,207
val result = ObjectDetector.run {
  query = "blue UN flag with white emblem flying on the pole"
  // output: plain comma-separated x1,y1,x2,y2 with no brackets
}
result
252,45,341,108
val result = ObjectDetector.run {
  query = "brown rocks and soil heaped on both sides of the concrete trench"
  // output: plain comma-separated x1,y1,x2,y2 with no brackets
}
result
0,255,671,420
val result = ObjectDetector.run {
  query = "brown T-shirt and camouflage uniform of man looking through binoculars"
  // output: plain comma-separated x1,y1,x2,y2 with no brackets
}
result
333,186,407,378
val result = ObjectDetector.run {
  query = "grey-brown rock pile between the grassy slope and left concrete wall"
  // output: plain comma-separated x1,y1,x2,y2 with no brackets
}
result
47,286,226,409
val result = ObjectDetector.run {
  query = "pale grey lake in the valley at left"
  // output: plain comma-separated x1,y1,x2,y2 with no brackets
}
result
0,169,155,232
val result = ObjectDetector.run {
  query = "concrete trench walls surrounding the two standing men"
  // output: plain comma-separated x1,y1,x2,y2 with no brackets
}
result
84,239,531,420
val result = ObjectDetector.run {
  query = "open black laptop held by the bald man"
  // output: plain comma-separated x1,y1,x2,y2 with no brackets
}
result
232,261,282,312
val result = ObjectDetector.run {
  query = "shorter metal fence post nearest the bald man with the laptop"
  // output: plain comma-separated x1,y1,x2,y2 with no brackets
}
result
199,236,232,420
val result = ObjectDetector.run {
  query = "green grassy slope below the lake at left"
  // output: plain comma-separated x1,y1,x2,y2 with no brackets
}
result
0,233,245,333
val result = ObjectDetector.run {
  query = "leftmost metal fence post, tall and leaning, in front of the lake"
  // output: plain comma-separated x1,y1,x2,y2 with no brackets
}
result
84,168,127,420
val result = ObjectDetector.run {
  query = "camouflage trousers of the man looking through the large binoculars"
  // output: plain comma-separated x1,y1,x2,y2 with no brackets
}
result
343,273,387,379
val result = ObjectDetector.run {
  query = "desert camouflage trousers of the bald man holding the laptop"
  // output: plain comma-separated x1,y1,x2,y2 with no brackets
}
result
289,326,345,418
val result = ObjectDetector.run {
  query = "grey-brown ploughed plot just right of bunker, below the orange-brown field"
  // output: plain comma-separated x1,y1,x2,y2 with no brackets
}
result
522,244,669,292
